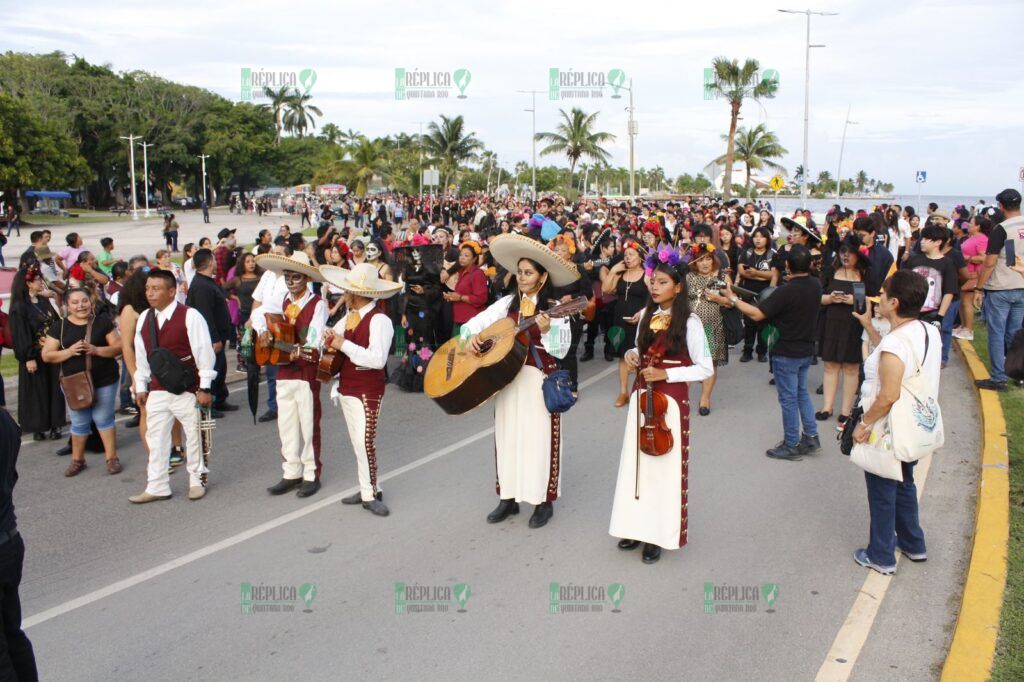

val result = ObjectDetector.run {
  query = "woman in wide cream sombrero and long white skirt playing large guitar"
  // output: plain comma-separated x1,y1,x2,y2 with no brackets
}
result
462,235,580,528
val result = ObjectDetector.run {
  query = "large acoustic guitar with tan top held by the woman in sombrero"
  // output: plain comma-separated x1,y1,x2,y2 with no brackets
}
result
423,296,587,415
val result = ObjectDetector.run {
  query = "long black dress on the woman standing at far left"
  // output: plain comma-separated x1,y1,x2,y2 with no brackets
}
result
10,298,68,433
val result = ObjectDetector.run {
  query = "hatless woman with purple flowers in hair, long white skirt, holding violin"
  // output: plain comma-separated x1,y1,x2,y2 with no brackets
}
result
608,249,715,563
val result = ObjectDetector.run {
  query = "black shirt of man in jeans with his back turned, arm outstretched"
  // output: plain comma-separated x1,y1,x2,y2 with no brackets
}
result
758,276,821,357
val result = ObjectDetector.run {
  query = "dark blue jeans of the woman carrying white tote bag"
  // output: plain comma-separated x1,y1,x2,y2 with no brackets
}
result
864,462,925,566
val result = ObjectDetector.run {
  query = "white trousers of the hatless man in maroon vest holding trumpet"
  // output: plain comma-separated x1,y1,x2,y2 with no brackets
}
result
145,391,210,496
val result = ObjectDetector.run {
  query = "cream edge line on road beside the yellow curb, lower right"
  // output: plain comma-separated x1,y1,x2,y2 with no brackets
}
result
814,448,932,682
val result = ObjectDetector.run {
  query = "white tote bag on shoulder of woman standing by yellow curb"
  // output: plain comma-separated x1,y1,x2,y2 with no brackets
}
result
886,323,945,462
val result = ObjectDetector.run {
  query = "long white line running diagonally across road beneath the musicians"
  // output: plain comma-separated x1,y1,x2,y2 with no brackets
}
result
22,365,618,630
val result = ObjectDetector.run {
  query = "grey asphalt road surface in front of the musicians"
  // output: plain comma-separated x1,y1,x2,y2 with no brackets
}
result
15,342,978,680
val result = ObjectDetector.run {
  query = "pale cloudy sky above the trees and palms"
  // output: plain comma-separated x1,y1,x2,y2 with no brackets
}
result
0,0,1024,198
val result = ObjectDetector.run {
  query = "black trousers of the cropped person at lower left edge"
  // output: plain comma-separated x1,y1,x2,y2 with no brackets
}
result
0,536,39,682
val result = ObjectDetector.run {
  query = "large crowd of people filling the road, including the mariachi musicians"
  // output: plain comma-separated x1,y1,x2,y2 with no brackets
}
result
0,184,1024,570
